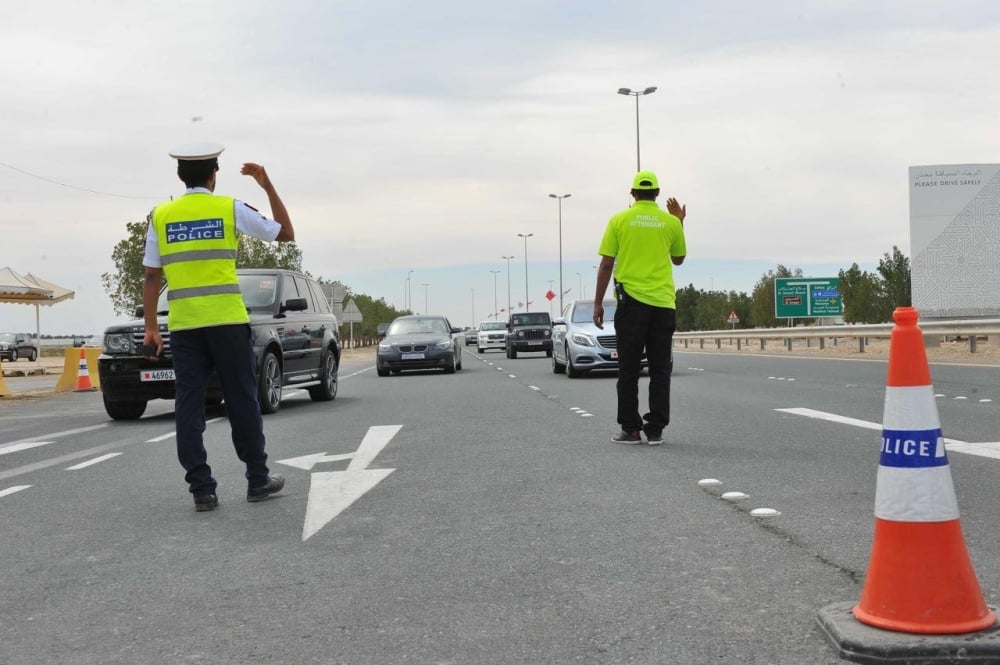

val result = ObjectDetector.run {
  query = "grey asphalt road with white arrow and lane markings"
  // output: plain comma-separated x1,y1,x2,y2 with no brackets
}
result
0,349,1000,665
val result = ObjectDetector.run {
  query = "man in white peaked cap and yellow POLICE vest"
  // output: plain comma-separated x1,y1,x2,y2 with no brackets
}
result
142,143,295,512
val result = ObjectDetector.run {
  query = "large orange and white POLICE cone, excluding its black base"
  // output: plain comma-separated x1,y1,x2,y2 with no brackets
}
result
852,307,997,634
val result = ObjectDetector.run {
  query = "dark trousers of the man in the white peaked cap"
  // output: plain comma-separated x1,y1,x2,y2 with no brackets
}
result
170,324,268,495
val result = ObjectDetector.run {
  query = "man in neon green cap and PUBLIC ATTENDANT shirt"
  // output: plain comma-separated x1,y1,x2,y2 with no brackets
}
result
594,171,687,446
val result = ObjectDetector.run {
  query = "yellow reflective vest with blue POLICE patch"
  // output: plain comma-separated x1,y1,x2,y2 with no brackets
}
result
153,192,250,331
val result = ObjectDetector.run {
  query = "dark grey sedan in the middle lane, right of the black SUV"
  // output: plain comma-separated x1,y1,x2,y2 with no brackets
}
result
375,314,462,376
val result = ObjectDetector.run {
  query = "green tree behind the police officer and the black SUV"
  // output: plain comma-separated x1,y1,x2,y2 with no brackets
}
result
101,215,302,316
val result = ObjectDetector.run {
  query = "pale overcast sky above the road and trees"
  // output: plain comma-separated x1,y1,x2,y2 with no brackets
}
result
0,0,1000,333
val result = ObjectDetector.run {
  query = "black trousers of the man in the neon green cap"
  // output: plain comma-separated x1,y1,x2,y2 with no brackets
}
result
615,294,677,435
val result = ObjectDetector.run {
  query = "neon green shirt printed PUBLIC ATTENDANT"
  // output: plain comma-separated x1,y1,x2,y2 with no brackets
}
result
597,201,687,309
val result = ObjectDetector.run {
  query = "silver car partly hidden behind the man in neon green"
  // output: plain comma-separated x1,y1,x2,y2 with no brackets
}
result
552,299,649,379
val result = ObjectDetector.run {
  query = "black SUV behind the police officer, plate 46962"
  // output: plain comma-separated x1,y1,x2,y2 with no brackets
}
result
98,268,340,420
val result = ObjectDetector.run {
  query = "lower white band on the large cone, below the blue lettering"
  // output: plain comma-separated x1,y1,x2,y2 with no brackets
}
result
875,466,958,522
